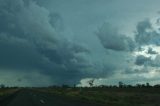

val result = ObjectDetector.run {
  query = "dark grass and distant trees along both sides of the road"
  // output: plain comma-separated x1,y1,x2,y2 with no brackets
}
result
0,82,160,106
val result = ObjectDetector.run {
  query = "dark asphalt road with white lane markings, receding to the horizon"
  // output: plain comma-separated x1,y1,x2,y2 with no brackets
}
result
0,90,99,106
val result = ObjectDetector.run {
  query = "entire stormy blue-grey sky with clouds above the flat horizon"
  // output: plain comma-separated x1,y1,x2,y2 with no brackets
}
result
0,0,160,86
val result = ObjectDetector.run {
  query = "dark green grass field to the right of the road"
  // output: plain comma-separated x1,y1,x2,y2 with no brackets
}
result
35,88,160,106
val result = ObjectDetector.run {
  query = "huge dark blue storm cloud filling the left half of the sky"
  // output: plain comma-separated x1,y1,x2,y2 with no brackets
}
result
0,0,90,84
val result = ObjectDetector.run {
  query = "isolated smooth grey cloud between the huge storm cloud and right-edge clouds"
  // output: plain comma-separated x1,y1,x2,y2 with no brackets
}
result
96,23,135,51
